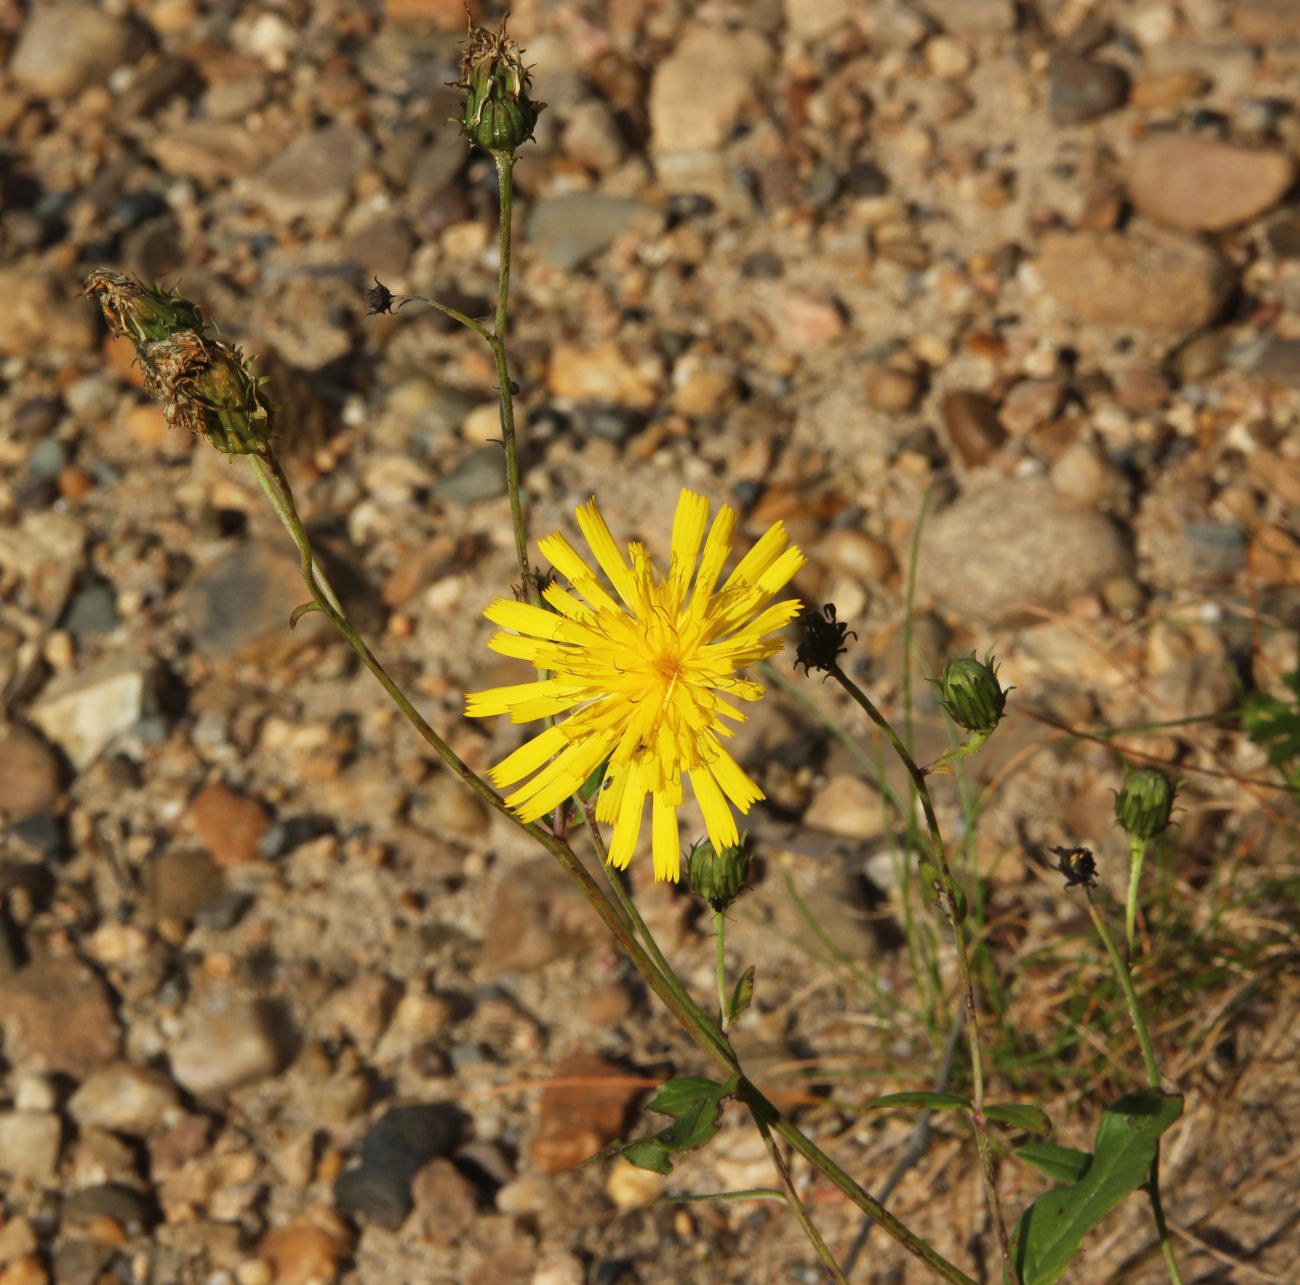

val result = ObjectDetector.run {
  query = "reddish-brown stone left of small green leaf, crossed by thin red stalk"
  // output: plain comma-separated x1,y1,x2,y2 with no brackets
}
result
530,1053,641,1173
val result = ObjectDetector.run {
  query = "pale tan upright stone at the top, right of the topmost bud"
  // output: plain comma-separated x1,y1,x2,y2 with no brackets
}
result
650,23,774,153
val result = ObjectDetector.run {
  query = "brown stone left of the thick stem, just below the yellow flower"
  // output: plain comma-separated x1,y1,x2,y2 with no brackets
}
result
480,857,606,979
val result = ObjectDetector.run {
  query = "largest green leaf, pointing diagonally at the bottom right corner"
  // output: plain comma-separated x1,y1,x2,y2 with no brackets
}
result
1015,1089,1183,1285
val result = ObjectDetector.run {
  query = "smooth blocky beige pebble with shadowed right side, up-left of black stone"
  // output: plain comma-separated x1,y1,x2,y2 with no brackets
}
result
170,1000,293,1098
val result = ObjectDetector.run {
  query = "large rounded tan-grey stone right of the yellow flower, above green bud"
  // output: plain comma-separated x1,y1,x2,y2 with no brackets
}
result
918,477,1130,624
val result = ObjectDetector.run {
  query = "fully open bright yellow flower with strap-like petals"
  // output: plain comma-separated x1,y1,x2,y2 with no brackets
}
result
465,490,803,881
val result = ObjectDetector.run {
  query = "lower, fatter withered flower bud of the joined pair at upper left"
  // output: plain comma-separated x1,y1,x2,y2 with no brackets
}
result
139,330,276,455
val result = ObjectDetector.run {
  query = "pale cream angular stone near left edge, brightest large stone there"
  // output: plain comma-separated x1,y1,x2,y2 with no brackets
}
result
30,656,159,770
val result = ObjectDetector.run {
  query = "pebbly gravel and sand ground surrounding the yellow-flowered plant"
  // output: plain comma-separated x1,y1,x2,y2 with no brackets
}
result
0,0,1300,1285
